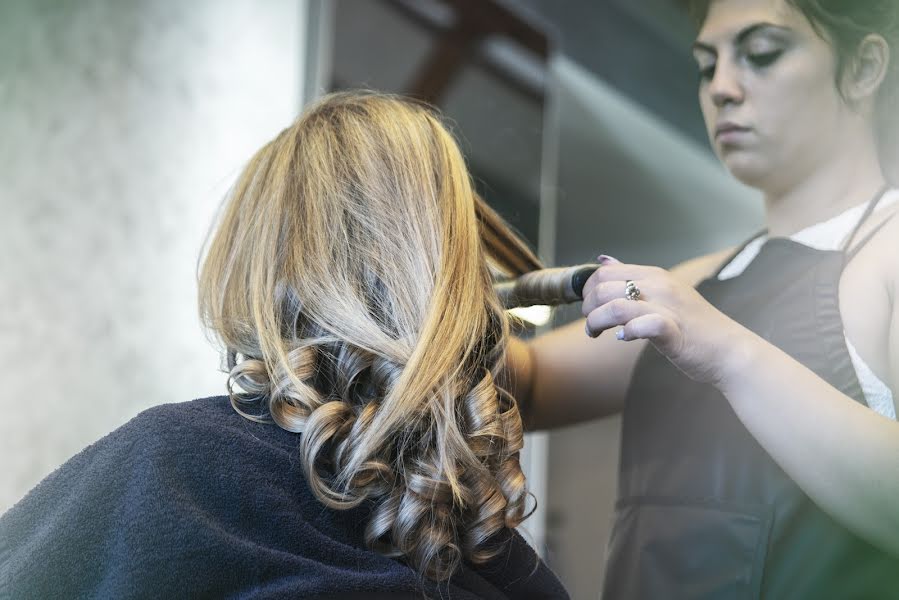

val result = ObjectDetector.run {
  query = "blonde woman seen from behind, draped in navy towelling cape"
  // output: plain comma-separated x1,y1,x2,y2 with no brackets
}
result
0,94,567,600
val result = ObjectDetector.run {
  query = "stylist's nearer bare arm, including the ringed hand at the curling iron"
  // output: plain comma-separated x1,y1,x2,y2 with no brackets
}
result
584,221,899,556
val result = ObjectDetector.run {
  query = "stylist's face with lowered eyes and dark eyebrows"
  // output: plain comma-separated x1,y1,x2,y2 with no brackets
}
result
693,0,847,189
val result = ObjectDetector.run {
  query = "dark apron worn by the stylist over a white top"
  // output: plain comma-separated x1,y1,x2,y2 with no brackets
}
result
603,194,899,600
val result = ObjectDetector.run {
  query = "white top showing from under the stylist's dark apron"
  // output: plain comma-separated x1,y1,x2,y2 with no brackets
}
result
718,189,899,420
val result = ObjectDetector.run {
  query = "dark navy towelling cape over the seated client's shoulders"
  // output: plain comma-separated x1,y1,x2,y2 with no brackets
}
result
0,397,568,600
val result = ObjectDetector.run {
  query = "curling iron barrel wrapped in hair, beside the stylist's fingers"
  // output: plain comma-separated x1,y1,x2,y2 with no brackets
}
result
493,264,599,309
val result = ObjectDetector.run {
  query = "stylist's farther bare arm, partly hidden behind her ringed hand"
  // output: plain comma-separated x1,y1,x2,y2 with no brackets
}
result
508,250,730,430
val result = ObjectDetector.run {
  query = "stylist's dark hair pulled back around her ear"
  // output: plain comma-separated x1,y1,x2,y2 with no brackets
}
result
683,0,899,182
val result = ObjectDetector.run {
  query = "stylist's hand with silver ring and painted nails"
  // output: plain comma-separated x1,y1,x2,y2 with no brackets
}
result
582,257,755,385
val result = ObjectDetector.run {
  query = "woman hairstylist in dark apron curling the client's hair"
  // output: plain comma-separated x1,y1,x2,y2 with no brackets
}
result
512,0,899,599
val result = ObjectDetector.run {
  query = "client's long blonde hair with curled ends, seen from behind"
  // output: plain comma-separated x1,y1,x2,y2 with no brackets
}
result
199,92,540,580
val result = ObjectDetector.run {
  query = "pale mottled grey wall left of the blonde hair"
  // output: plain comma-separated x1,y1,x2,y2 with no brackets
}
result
0,0,302,512
